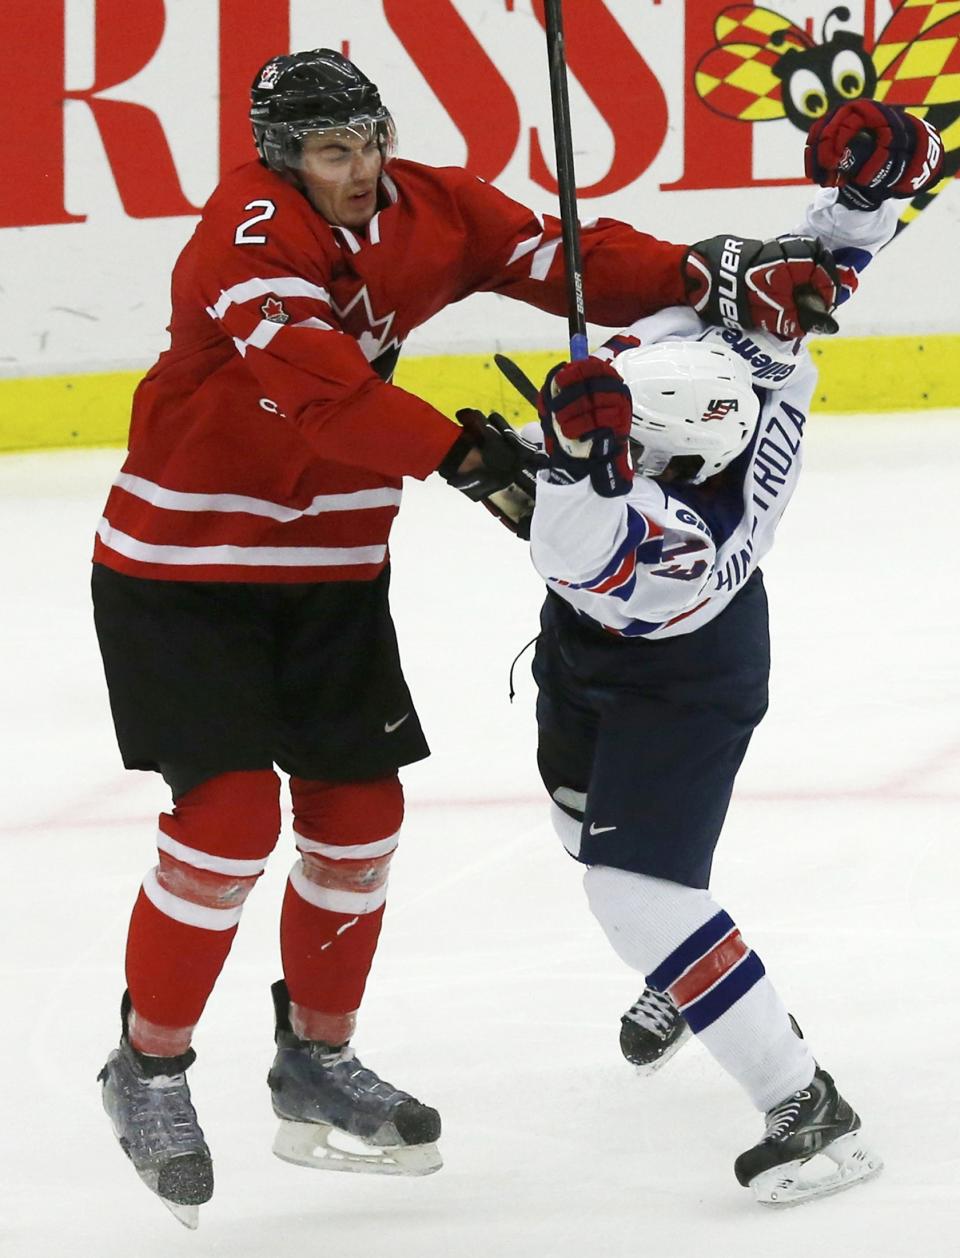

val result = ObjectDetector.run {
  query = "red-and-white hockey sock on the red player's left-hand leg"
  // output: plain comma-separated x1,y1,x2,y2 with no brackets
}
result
126,770,281,1057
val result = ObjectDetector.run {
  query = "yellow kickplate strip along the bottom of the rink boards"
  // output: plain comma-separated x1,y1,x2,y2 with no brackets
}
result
0,335,960,450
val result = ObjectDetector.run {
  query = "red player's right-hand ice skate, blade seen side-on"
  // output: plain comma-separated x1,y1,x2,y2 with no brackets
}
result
267,982,443,1175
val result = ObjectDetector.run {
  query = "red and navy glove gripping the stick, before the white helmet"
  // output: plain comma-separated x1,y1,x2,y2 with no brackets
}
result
537,357,633,498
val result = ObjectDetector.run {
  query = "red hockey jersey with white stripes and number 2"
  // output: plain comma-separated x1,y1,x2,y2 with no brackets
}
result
94,160,683,581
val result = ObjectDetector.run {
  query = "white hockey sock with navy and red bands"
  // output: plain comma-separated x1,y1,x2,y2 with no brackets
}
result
584,866,817,1112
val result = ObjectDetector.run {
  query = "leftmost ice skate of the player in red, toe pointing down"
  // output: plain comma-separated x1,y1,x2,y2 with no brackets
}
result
97,1034,214,1228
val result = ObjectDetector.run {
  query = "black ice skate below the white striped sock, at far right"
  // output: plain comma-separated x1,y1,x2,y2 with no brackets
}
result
734,1067,883,1205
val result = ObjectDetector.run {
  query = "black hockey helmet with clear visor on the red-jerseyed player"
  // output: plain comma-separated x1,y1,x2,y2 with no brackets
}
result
250,48,396,171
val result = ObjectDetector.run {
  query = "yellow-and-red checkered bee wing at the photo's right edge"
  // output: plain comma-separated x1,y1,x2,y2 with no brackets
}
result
872,11,960,107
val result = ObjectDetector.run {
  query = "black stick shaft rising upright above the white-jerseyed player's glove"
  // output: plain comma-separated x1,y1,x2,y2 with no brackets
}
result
543,0,590,364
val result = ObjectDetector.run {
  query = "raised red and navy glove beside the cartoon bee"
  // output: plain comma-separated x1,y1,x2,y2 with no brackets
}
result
804,99,944,210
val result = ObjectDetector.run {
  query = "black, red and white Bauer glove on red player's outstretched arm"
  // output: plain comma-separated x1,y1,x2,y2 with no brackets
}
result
683,235,839,341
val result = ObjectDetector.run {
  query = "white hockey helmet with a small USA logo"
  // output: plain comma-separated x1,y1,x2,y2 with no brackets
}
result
613,341,760,484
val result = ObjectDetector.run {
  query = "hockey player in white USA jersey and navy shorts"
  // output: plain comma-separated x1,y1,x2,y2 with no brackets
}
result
531,102,939,1204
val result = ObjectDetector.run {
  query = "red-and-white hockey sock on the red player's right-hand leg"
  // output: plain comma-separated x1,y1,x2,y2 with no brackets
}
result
281,776,404,1044
